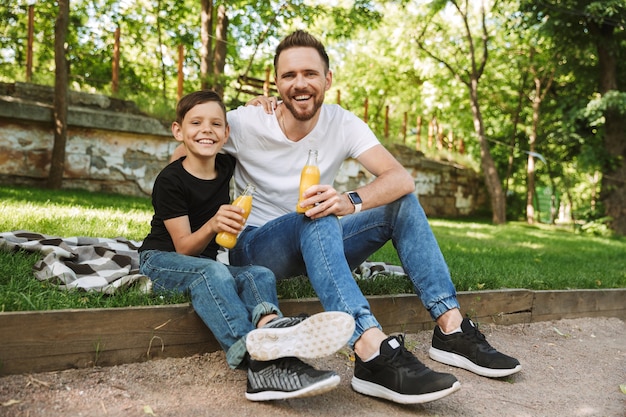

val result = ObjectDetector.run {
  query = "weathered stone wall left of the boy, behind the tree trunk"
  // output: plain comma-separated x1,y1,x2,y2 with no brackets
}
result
0,83,177,196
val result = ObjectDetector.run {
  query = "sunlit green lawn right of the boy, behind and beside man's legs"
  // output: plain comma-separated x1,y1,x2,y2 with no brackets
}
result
373,219,626,291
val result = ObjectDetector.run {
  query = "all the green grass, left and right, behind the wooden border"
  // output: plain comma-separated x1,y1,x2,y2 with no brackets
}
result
0,187,626,311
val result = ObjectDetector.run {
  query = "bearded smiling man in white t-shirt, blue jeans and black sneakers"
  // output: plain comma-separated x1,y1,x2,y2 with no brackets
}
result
175,31,521,403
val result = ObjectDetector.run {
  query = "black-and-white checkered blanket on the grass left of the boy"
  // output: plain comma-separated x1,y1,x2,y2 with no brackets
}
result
0,230,152,294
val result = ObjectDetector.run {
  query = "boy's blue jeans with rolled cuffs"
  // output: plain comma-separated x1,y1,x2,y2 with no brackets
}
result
139,250,282,368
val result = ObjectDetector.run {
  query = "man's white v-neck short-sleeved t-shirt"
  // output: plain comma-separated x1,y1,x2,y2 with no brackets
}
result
223,104,380,226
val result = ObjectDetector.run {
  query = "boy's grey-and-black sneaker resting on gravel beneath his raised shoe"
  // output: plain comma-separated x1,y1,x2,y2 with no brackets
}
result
246,358,339,401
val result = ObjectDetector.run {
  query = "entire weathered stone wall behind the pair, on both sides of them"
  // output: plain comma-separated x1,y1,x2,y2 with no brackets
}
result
0,83,486,217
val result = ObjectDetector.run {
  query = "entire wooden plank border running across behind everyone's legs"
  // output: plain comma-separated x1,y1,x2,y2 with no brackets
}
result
0,289,626,375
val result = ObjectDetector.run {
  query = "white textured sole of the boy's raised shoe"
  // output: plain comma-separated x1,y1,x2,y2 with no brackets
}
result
246,311,355,361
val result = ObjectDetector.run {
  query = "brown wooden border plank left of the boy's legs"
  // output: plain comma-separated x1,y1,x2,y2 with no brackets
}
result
0,304,220,374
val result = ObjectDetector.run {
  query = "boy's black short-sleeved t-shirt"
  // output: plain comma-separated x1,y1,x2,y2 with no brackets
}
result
139,154,235,259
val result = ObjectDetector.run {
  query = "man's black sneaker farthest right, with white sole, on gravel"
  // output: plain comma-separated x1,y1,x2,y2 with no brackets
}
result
428,318,522,378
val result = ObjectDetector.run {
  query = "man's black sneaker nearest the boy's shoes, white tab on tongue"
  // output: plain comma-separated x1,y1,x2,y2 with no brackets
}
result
352,336,461,404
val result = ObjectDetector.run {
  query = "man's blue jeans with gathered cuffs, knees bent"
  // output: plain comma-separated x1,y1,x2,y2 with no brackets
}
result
229,194,459,345
